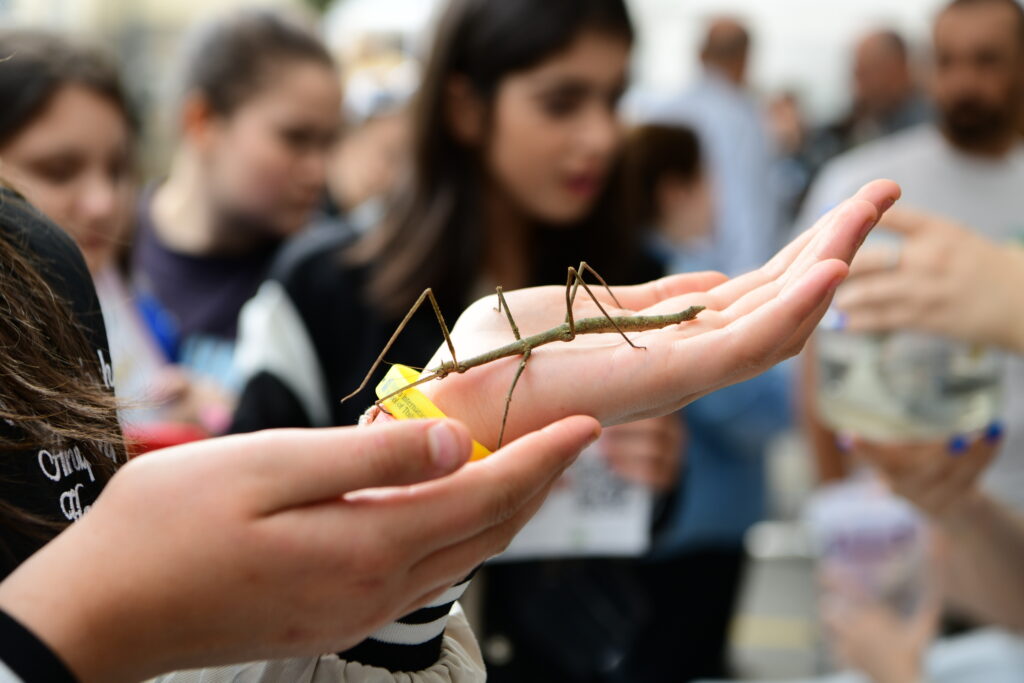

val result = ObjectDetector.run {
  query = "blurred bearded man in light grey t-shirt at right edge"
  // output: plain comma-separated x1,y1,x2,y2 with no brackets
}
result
797,0,1024,509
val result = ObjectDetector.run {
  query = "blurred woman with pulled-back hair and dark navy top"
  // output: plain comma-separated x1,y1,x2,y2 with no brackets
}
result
131,11,341,413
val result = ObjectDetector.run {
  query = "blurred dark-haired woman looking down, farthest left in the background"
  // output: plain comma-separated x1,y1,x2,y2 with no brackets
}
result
0,31,215,442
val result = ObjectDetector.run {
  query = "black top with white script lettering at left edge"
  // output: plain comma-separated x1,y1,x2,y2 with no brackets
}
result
0,189,114,683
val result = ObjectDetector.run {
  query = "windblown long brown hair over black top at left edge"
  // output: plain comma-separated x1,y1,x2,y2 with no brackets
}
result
0,187,124,559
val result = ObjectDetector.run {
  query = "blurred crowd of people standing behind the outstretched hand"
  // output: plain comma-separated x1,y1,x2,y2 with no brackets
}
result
0,0,1024,683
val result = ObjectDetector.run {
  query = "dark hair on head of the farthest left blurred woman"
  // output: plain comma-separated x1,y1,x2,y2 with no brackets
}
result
0,31,137,146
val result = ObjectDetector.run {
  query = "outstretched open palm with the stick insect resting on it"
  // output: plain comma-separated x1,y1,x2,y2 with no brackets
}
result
420,180,900,447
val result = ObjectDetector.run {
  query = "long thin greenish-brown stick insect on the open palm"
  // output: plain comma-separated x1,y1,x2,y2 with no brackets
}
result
341,261,705,447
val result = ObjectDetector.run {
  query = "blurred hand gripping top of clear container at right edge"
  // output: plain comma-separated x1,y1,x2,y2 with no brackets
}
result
836,207,1024,353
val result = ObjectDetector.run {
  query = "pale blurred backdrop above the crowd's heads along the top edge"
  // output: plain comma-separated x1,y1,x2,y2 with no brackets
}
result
0,0,943,168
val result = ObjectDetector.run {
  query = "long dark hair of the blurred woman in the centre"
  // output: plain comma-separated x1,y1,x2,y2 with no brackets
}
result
348,0,633,314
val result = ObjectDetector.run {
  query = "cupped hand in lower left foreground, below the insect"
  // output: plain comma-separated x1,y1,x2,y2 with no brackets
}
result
0,417,600,681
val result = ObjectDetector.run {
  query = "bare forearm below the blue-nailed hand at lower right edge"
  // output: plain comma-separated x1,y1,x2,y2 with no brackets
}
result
938,494,1024,630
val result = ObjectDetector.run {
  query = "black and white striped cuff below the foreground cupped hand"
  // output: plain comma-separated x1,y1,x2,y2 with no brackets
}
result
338,571,475,672
